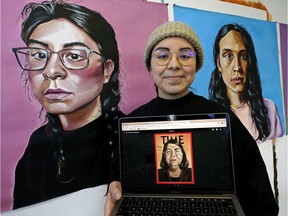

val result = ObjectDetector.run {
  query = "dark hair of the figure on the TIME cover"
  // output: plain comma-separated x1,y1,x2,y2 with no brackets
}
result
160,138,189,170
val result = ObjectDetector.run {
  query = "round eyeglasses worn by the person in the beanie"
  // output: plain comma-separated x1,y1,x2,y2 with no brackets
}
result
152,49,197,66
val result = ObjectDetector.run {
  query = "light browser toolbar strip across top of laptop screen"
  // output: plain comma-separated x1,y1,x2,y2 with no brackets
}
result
122,118,227,131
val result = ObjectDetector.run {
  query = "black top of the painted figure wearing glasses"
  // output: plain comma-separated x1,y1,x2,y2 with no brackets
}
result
13,115,117,209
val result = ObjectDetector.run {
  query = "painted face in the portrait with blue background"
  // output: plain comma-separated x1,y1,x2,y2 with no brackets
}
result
217,30,248,96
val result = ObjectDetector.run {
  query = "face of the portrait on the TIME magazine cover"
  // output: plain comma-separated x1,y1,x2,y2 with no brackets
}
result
165,144,183,170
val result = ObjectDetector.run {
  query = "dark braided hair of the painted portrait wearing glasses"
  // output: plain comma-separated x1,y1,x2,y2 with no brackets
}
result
21,0,120,145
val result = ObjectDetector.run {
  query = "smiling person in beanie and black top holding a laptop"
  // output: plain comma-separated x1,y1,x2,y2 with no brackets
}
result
105,22,279,216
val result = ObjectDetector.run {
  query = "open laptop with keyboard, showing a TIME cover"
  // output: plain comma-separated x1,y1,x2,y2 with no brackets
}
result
111,113,244,216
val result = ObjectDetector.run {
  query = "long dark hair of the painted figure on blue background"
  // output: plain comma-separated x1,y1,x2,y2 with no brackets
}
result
208,23,271,140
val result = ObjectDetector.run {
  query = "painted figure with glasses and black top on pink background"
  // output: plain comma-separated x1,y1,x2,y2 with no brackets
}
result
12,0,123,209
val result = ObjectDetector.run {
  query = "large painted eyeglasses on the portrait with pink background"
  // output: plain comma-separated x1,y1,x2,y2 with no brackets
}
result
12,47,103,71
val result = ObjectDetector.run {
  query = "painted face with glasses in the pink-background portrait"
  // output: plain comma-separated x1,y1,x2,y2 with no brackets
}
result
27,19,113,114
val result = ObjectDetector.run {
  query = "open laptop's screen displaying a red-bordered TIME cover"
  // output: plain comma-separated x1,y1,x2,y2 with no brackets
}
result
119,113,234,194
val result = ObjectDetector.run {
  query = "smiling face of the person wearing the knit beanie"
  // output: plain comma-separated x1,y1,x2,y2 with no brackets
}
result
150,37,196,99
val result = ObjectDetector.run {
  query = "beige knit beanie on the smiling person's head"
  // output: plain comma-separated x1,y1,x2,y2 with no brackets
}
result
144,21,204,72
